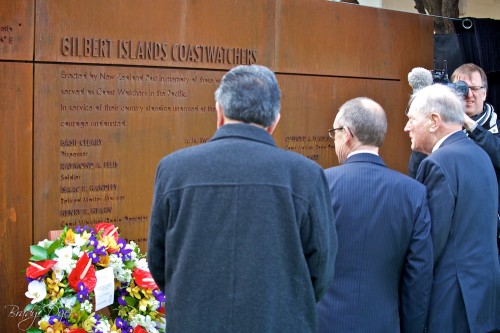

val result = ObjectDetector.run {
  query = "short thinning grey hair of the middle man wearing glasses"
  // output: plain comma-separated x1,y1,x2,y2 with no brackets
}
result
337,97,387,147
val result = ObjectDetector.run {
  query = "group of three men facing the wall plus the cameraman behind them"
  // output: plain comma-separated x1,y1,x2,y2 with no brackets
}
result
148,64,500,333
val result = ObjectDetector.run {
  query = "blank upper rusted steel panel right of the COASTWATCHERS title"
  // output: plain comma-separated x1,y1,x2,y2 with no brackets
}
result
275,0,433,80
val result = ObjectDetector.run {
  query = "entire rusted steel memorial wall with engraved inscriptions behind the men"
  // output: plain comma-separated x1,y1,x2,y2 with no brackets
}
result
0,0,433,332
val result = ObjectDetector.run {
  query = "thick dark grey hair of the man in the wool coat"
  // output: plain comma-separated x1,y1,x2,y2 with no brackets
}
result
215,65,281,127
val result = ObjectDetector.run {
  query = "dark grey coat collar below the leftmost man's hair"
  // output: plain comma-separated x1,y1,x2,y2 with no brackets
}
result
209,123,276,146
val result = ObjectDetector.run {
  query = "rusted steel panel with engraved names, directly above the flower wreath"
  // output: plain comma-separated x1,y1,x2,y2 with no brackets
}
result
34,64,224,246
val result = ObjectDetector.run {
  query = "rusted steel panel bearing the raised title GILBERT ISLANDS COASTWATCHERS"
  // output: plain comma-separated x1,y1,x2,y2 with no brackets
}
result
35,0,276,69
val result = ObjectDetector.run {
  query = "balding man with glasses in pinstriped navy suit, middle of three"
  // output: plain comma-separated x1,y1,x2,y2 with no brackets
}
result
317,98,433,333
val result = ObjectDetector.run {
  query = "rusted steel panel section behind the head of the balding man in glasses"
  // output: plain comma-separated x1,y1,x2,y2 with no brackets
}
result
274,75,409,168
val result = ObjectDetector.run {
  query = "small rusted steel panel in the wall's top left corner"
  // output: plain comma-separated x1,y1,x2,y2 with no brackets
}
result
0,0,35,60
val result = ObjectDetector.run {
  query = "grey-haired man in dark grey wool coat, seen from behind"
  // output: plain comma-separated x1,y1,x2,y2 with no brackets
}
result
148,65,337,333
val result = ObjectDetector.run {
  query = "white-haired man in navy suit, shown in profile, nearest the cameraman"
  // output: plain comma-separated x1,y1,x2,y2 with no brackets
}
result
405,84,500,333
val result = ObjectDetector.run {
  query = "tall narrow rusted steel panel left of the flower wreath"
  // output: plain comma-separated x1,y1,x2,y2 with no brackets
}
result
0,61,33,332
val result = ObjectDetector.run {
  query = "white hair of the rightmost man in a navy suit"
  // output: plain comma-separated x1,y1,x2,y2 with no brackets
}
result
409,84,465,124
